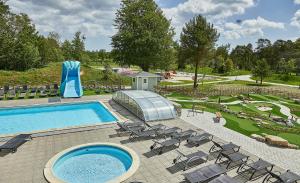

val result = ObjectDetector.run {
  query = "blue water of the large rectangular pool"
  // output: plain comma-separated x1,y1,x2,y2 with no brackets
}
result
0,102,117,135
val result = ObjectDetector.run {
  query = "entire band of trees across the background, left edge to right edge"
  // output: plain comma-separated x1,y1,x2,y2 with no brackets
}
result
0,0,300,87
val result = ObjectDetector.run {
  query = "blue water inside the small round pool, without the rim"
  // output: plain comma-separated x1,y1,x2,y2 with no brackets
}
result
52,145,132,183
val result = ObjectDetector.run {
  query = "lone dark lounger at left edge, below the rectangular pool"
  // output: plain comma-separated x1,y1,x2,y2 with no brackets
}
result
0,134,31,153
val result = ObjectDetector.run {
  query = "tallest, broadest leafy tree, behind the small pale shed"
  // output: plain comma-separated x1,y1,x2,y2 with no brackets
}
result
112,0,174,71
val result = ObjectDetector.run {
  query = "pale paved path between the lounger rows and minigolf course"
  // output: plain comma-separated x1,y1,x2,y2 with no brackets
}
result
181,109,300,174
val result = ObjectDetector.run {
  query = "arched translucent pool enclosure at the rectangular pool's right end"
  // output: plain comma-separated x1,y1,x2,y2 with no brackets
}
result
113,90,177,121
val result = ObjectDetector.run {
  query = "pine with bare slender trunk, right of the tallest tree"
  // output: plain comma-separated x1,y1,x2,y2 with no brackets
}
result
180,15,219,88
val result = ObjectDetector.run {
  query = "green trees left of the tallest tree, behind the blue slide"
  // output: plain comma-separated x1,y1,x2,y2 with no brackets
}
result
0,0,109,71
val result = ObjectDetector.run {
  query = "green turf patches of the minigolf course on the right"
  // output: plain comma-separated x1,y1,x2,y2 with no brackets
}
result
173,94,300,146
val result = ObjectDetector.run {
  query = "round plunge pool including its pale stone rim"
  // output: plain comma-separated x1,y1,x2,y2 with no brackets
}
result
44,143,139,183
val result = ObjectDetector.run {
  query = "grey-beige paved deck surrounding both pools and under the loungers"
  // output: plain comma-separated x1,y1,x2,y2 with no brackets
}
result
0,95,297,183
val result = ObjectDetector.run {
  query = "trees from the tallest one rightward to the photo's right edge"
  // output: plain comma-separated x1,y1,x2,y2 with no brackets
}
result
112,0,300,87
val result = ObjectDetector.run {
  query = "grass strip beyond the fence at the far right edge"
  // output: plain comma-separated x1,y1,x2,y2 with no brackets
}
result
252,74,300,86
